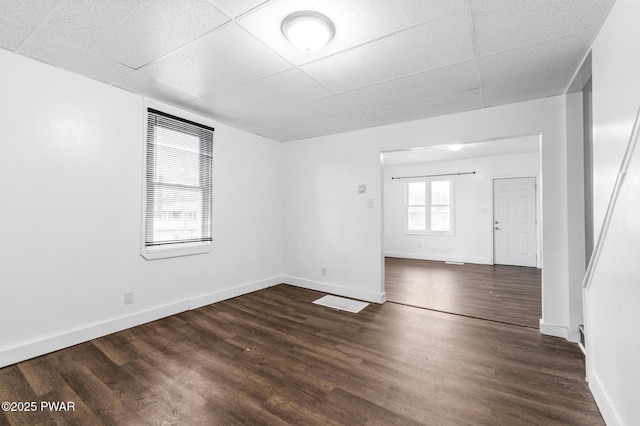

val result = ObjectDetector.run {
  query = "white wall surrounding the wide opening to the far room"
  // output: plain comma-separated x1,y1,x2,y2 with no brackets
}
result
284,96,577,339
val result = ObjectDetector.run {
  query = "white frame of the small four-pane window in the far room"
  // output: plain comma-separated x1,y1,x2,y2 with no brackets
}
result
404,177,455,236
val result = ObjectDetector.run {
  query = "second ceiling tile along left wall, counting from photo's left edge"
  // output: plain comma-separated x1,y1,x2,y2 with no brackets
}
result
20,34,133,83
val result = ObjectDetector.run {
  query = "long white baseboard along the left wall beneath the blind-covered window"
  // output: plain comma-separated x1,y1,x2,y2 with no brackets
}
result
0,276,283,367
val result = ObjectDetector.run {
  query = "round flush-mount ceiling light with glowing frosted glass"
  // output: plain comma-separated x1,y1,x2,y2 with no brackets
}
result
282,11,336,52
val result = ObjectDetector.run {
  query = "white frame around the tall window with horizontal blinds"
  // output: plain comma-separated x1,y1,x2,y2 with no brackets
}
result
140,99,214,260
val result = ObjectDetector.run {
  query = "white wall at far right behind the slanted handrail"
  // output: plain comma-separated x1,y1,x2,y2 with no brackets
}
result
585,1,640,425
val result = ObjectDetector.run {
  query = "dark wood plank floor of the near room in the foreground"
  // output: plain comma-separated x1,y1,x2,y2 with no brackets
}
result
0,285,603,425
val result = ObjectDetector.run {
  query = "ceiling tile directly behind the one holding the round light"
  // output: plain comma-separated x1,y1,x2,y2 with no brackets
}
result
301,13,473,91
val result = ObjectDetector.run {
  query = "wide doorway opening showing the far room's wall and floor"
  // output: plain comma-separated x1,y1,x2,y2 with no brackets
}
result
381,134,542,329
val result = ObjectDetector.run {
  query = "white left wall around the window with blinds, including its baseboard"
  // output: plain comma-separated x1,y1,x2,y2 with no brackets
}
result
0,50,282,366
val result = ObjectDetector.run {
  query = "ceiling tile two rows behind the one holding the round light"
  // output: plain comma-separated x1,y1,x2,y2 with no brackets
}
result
340,61,480,111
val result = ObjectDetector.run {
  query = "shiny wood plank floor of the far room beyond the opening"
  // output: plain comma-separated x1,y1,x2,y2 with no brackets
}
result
385,258,542,329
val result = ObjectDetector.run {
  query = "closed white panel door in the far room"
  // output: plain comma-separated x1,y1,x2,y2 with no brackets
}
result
493,177,536,266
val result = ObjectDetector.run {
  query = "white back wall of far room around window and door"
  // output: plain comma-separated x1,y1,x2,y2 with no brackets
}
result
384,152,540,264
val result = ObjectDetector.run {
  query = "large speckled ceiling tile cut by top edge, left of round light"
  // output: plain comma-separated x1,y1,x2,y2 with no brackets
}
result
43,0,228,68
